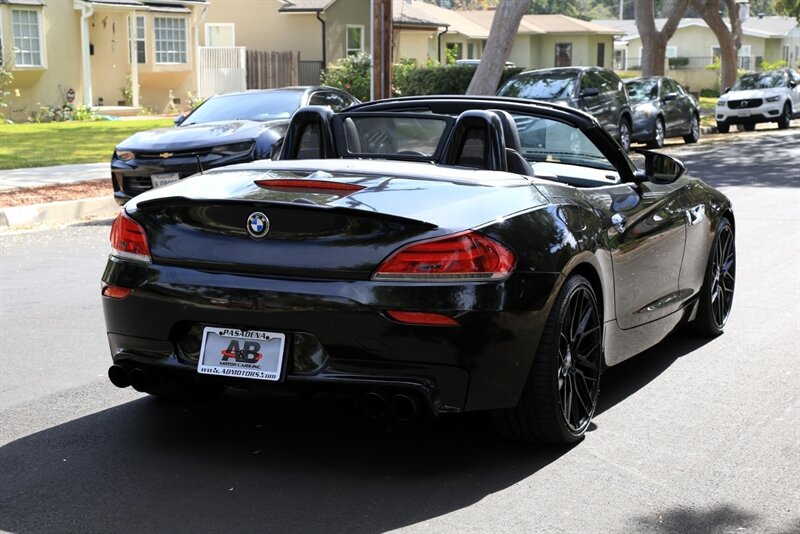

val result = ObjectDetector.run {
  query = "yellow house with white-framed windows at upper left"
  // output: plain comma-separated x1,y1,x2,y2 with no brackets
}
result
0,0,208,120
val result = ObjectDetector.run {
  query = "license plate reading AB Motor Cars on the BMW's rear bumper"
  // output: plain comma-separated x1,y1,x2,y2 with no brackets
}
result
197,326,286,382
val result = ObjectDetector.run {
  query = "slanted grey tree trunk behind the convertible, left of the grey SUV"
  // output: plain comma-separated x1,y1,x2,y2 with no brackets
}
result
467,0,530,95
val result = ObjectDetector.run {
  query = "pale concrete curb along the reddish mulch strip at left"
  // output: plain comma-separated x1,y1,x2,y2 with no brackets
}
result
0,195,120,228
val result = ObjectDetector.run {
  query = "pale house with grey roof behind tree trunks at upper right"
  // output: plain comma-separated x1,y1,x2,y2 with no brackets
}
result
593,13,800,90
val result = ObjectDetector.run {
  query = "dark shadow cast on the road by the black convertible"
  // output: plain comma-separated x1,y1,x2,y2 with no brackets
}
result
0,338,712,533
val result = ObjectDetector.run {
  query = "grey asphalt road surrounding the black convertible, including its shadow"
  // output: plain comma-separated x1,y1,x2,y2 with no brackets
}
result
0,128,800,533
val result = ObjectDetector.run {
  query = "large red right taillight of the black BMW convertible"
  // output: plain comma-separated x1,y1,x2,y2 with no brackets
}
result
373,232,516,282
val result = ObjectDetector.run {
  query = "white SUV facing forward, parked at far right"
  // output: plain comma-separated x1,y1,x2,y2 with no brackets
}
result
716,69,800,133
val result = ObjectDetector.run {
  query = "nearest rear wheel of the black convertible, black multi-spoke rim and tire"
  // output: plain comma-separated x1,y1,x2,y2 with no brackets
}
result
492,275,603,445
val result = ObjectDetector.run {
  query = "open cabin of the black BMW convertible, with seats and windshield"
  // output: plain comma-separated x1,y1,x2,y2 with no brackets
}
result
278,106,621,187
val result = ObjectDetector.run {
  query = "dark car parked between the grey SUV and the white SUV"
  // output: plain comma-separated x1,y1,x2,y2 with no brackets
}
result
625,76,700,148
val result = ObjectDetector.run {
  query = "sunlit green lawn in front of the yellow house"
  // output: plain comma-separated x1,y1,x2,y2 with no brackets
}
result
0,119,172,169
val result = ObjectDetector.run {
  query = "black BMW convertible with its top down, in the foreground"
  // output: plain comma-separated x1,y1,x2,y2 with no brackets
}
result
102,96,736,443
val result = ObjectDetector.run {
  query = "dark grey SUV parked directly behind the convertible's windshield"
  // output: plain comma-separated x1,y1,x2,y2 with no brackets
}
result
497,67,633,151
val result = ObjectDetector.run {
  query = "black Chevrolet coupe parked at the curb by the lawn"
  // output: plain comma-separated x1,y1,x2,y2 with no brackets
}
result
111,87,359,204
